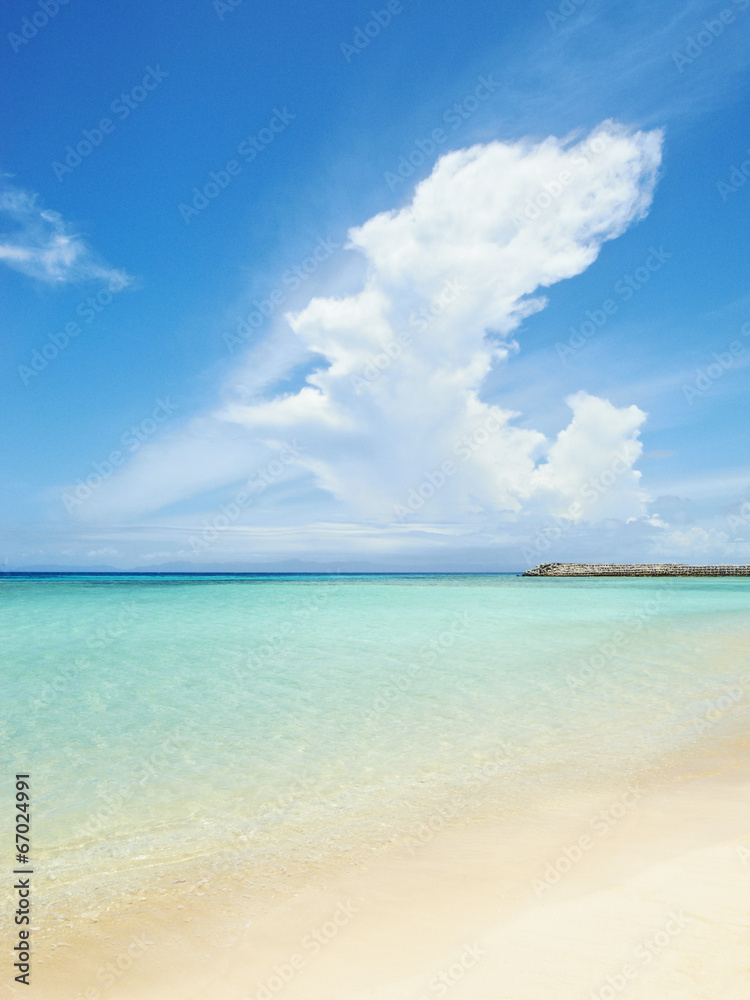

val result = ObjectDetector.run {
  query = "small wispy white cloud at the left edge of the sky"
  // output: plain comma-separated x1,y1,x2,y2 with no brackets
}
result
0,175,133,291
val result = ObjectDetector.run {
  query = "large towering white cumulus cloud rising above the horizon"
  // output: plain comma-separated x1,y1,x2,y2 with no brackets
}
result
64,122,662,556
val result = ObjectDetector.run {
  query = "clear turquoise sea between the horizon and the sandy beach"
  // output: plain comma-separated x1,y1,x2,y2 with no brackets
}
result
0,575,750,916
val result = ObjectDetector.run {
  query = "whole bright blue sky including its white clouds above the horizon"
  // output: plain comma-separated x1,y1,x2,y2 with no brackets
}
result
0,0,750,570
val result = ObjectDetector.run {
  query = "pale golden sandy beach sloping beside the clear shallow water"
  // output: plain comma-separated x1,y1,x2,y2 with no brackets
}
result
25,734,750,1000
